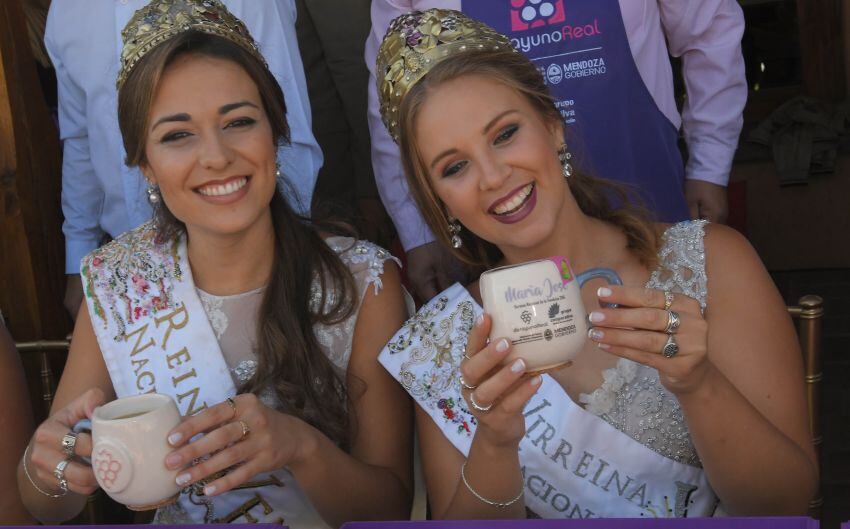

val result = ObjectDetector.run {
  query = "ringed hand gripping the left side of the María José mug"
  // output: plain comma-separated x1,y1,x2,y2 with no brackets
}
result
460,315,542,446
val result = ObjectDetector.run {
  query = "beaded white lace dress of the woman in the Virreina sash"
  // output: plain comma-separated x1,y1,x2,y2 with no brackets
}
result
579,221,708,466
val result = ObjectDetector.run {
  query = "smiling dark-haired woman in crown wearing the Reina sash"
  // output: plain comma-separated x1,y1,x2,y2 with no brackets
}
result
14,0,411,527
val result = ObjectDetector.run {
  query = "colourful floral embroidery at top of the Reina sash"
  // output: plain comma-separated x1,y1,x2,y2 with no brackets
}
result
80,222,183,341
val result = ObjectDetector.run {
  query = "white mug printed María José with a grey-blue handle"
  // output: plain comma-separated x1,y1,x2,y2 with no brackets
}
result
479,256,623,373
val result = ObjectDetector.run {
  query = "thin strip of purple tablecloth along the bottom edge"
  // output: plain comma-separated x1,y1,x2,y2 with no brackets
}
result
342,517,816,529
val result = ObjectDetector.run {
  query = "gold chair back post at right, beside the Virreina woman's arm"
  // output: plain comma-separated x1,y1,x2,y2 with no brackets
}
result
788,295,824,518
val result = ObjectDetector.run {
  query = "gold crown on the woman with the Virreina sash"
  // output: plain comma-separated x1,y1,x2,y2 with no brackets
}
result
375,9,516,143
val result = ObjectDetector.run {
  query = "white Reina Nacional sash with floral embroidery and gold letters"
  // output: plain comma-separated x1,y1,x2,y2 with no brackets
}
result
81,222,327,527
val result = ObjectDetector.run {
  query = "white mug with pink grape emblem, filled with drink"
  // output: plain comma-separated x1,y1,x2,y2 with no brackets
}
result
74,393,180,511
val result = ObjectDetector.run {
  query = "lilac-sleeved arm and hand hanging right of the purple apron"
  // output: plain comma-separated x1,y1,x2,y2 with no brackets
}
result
658,0,747,222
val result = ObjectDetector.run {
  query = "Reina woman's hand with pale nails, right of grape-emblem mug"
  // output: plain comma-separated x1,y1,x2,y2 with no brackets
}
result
165,393,303,496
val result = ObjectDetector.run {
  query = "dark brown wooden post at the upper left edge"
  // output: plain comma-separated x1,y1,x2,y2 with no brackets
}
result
0,0,69,341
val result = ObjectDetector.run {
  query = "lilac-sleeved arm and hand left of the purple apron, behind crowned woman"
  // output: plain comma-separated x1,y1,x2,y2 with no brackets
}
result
365,0,460,301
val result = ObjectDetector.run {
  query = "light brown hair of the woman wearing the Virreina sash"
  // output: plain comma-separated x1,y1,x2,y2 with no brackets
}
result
399,49,658,269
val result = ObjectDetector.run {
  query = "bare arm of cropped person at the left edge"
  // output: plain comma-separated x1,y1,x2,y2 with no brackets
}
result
0,314,35,525
